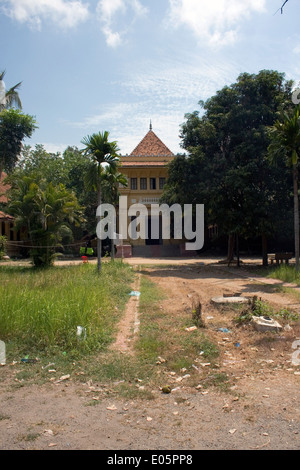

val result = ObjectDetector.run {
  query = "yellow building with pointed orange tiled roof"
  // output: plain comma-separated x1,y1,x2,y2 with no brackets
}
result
117,124,192,257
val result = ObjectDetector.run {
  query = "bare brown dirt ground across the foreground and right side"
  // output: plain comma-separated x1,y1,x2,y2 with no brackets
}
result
0,260,300,451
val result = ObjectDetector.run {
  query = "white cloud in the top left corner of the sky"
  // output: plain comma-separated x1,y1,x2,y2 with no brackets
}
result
2,0,89,29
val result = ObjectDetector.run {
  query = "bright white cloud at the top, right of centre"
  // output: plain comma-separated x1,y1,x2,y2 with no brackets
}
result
168,0,266,46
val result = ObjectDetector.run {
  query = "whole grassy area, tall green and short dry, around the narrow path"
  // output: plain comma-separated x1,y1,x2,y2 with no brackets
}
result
0,261,224,394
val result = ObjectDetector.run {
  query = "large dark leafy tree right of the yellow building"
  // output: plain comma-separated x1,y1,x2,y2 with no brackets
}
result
165,70,292,262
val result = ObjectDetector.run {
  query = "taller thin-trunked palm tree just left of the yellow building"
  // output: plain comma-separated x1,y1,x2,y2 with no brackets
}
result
81,131,119,272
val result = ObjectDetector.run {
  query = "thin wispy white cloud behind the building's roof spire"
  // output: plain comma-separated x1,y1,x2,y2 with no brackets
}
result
63,56,238,154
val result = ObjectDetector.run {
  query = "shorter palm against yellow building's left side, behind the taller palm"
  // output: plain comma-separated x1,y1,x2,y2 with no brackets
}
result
102,166,128,261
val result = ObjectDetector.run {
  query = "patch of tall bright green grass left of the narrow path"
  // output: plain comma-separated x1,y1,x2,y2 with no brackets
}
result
0,261,133,351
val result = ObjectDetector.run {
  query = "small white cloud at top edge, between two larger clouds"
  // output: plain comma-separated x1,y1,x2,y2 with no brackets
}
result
97,0,148,47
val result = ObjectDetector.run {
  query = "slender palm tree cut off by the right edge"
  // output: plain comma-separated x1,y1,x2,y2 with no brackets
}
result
269,106,300,271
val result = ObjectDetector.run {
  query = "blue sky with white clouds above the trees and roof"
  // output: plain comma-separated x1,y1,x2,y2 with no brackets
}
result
0,0,300,154
